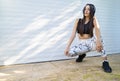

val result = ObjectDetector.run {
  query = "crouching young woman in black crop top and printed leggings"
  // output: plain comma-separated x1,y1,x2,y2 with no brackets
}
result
64,4,112,73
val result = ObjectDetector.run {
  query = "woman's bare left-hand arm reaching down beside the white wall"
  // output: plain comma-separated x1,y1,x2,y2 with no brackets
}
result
65,19,79,55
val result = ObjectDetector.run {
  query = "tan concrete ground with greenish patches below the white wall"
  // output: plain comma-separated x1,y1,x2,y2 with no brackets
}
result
0,54,120,81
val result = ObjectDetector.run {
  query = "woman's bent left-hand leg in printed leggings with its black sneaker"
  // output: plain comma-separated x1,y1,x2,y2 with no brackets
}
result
69,38,93,62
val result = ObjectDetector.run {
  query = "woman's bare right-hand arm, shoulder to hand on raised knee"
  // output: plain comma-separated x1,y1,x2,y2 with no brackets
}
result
93,17,103,51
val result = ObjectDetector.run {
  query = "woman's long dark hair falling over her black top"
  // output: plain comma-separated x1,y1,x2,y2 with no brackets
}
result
77,4,96,37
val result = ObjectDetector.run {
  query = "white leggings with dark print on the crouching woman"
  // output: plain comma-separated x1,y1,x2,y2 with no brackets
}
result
69,36,107,57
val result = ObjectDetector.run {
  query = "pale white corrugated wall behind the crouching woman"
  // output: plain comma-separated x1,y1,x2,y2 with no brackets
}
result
0,0,120,65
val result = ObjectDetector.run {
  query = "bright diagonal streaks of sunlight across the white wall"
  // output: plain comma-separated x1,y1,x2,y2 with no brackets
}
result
4,2,82,65
